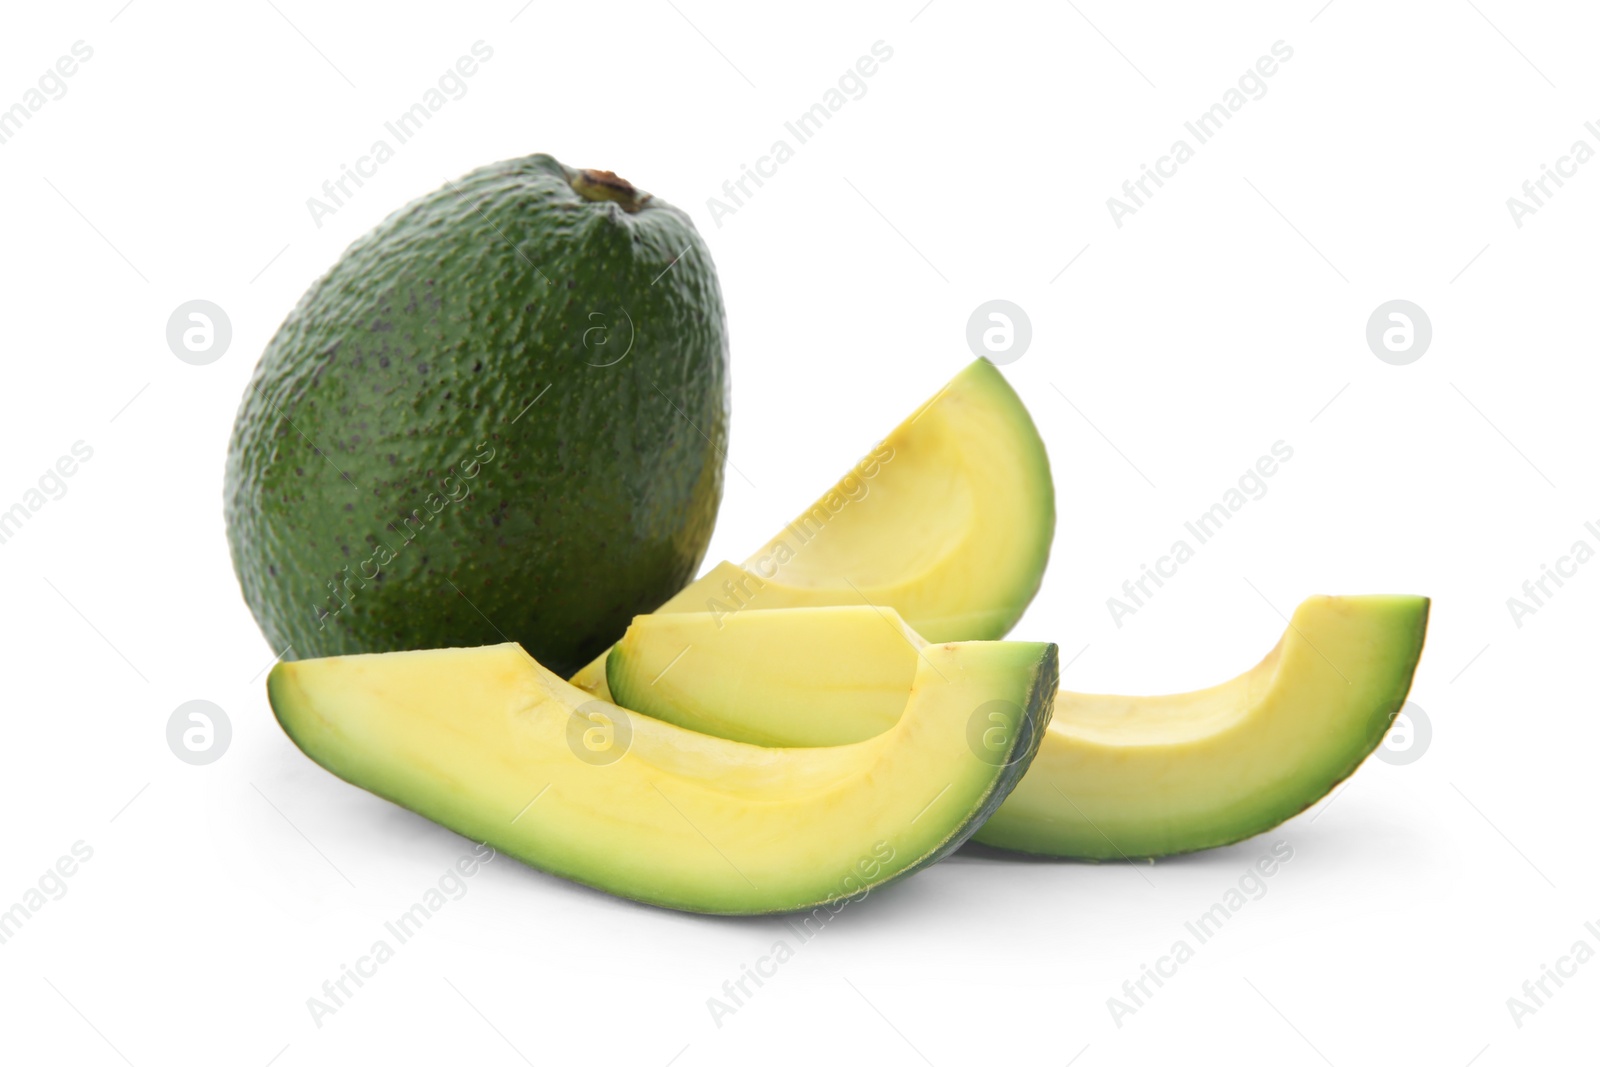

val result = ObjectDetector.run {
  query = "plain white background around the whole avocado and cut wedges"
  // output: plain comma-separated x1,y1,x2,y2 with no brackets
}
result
0,0,1600,1067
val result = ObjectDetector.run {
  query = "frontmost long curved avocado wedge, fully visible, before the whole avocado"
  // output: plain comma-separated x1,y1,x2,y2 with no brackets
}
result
267,641,1056,915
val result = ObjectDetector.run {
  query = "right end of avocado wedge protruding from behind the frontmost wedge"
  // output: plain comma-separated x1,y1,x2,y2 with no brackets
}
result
978,597,1429,859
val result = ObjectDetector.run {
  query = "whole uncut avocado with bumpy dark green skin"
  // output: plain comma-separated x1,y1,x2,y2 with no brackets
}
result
224,155,728,677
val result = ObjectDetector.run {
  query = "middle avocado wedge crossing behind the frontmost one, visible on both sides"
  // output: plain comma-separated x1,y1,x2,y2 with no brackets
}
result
610,597,1429,859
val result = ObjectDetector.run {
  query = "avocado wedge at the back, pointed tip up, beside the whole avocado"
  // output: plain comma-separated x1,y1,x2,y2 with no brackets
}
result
573,360,1056,697
